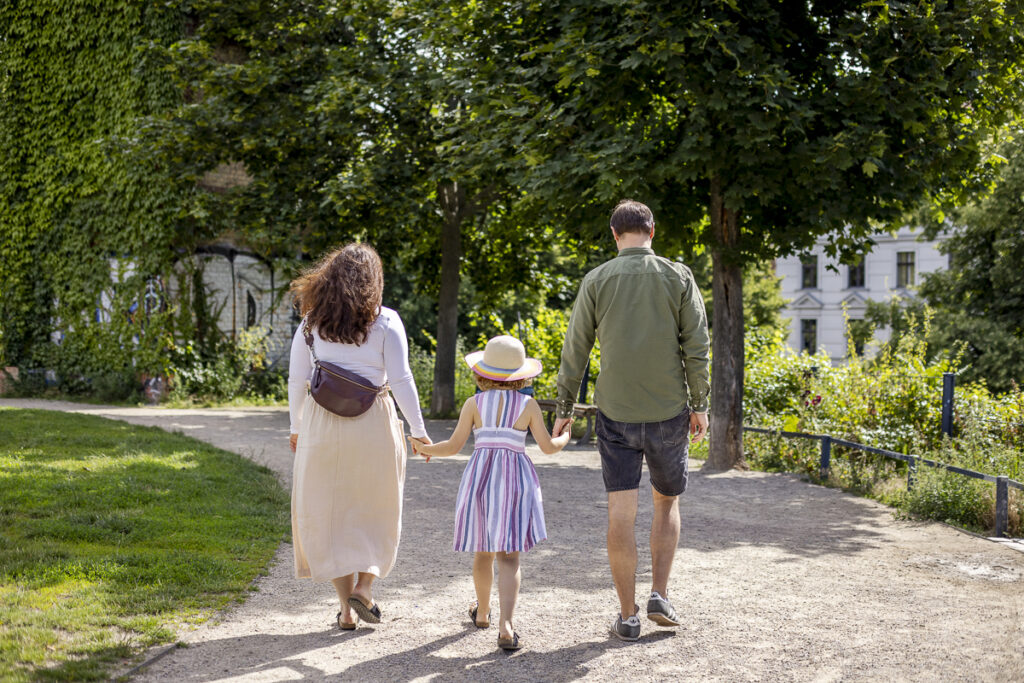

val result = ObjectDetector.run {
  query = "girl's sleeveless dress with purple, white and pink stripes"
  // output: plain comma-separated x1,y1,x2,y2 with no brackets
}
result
455,389,548,553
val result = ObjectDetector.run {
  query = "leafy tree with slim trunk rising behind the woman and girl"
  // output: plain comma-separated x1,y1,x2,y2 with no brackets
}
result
138,0,577,414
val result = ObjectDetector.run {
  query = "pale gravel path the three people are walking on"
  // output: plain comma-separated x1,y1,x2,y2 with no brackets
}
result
0,400,1024,683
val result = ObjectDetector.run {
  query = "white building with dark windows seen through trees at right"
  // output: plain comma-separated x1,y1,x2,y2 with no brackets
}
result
775,227,949,362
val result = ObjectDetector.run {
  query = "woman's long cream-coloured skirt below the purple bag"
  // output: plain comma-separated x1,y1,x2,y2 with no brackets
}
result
292,394,406,581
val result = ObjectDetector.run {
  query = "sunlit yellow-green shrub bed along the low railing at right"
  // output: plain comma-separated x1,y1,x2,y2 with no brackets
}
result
743,314,1024,533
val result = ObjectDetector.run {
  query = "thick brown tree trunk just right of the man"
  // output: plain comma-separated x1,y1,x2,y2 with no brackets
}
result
702,178,745,472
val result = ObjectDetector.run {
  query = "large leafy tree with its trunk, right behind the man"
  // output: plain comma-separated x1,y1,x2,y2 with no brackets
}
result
442,0,1024,469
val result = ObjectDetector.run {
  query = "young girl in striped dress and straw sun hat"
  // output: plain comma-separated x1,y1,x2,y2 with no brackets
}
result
413,336,569,650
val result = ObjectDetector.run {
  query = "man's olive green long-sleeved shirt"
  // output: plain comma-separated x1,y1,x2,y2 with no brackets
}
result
557,247,711,422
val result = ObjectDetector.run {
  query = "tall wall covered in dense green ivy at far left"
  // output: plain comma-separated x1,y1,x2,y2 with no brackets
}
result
0,0,188,378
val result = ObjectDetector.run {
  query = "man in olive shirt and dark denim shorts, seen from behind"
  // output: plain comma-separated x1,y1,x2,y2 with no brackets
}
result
552,200,710,640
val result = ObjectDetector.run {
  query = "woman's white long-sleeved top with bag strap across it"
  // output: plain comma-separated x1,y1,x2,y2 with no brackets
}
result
288,306,427,437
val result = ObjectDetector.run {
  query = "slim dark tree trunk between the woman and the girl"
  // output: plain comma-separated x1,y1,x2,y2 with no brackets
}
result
430,182,465,416
